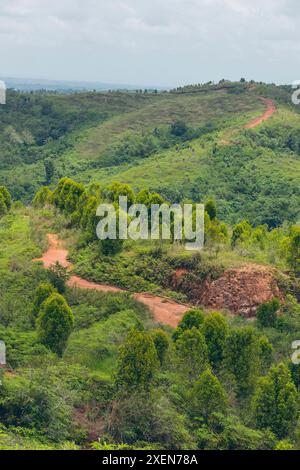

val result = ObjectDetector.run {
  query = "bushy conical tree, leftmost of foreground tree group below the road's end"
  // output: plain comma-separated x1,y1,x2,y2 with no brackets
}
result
116,329,159,391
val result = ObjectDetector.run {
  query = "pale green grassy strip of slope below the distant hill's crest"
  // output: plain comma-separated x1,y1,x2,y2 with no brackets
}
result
68,92,263,159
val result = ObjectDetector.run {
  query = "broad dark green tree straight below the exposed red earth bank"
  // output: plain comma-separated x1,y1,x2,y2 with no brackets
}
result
224,327,260,395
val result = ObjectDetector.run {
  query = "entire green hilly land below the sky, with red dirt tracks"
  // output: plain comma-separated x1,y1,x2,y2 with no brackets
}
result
0,81,300,452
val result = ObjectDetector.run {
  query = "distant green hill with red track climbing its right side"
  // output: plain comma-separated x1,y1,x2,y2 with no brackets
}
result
0,82,300,227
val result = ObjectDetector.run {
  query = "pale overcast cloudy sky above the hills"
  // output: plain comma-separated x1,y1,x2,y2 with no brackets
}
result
0,0,300,86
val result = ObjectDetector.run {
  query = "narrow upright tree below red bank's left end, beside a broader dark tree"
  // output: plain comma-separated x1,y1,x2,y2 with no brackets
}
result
201,312,229,368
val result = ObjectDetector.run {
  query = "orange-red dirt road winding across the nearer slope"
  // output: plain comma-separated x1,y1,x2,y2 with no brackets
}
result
33,233,190,328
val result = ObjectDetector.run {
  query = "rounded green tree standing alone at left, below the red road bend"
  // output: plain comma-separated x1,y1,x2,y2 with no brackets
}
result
37,293,74,356
